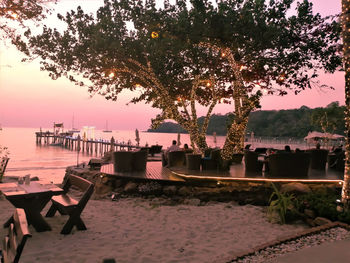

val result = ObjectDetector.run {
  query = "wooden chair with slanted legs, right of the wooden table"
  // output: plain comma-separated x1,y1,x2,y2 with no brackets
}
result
46,175,94,235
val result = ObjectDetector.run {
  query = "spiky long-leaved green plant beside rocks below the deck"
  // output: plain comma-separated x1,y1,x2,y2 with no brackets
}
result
267,183,294,224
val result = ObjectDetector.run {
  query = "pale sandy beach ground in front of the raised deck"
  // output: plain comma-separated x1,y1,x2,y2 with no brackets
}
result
0,195,307,263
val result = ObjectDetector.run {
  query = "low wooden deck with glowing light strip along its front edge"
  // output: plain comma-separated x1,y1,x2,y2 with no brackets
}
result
101,161,344,183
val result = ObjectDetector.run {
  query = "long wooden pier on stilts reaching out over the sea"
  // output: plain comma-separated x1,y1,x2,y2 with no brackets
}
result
35,131,141,156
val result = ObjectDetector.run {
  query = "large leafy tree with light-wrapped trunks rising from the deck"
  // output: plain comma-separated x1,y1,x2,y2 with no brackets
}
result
17,0,341,159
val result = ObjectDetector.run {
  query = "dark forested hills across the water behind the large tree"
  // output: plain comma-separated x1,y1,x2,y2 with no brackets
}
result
147,102,345,138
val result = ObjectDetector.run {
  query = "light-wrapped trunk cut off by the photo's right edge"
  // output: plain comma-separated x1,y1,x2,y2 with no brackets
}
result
341,0,350,209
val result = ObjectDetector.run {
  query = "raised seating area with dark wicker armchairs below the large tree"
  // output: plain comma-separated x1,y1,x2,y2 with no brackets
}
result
107,144,344,182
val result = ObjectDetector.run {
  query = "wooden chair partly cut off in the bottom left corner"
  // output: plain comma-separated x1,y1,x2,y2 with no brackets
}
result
1,208,32,263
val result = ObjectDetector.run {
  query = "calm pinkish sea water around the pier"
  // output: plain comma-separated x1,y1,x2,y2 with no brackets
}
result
0,127,225,183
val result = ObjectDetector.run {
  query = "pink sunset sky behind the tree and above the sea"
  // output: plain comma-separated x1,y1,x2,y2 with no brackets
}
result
0,0,345,130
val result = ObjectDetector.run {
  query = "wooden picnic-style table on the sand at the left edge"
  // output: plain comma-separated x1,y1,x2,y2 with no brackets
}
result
0,181,63,232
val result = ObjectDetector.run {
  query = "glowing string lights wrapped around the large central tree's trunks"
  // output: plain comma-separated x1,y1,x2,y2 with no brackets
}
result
101,43,257,160
